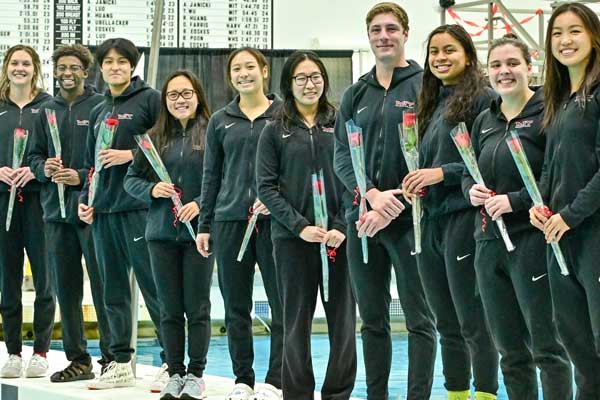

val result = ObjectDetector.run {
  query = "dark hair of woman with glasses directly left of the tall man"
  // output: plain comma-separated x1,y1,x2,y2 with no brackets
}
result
275,50,335,127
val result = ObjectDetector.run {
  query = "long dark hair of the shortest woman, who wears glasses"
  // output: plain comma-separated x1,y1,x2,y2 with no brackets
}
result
149,69,210,153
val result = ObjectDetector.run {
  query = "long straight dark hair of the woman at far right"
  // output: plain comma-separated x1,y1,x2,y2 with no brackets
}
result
543,3,600,127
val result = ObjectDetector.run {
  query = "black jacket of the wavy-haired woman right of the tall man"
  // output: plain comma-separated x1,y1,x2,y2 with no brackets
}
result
419,86,496,218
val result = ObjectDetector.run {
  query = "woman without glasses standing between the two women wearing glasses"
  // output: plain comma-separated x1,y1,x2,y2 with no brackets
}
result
196,47,283,400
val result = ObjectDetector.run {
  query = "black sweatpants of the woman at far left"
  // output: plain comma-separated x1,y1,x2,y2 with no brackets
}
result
0,192,55,354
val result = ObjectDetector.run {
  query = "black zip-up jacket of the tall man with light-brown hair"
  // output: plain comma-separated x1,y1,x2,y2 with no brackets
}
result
334,60,423,224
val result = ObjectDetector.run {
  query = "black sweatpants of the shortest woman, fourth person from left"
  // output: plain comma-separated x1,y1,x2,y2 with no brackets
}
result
148,240,214,377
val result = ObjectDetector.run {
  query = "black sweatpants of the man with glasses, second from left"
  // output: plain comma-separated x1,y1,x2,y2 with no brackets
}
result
45,222,112,363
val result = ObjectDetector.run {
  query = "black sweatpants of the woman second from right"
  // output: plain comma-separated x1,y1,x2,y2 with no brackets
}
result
475,230,573,400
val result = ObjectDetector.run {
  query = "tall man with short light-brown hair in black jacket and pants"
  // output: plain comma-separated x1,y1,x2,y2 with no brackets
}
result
334,2,436,400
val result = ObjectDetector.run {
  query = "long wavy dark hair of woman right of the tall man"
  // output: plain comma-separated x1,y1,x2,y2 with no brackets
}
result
417,25,488,135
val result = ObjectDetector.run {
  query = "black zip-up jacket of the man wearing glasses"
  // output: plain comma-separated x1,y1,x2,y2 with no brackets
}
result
29,85,104,224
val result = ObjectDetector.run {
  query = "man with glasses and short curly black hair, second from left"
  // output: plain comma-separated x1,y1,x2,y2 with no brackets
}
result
29,44,111,382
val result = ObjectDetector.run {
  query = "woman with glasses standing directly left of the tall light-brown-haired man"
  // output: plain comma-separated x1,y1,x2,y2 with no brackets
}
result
256,51,356,399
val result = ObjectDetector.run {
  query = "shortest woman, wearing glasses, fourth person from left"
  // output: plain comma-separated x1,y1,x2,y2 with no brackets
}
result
124,71,213,399
